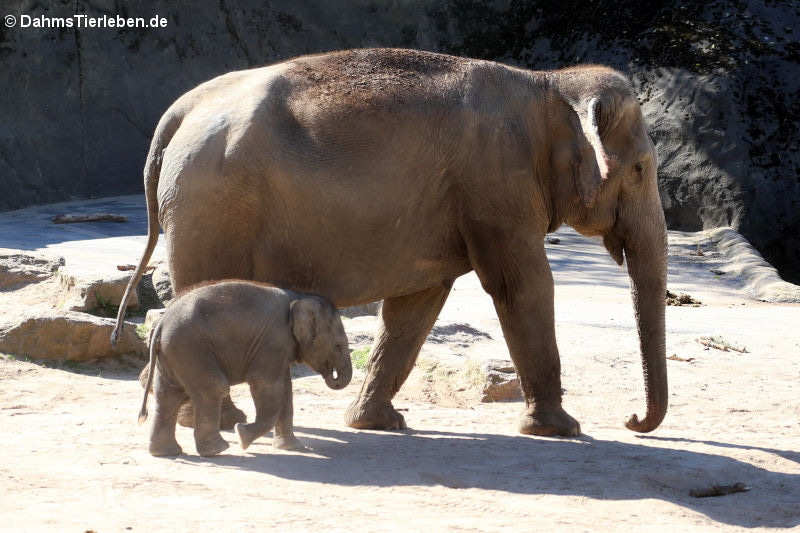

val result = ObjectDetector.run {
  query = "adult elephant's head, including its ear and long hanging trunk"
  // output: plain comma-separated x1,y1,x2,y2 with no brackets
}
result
554,67,668,432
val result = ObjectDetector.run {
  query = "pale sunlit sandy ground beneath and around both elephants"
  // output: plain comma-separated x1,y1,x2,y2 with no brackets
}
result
0,199,800,532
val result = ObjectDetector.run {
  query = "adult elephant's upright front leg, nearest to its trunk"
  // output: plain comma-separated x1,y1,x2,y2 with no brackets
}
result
470,231,581,437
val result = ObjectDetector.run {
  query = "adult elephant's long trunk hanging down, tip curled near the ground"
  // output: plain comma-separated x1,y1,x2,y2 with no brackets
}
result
604,200,669,433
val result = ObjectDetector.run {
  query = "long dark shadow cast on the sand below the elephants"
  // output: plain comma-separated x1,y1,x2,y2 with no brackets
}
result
179,428,800,528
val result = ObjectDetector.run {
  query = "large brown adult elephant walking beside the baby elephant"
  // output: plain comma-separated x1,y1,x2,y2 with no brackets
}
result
111,49,667,436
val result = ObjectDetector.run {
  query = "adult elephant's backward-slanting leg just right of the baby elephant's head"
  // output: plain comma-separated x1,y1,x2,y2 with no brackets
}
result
345,280,453,430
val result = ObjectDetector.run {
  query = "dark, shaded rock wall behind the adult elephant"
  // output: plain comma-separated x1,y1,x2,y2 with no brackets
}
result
0,0,800,282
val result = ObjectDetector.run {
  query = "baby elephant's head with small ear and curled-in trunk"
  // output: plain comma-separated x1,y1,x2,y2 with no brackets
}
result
290,296,353,389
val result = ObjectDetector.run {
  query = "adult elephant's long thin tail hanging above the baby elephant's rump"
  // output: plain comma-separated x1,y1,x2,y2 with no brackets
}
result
111,109,183,346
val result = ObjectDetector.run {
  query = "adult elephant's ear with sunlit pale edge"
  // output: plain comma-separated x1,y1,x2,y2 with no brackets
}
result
572,97,611,207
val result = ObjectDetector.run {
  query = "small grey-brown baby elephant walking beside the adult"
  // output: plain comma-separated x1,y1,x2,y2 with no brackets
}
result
139,281,353,456
